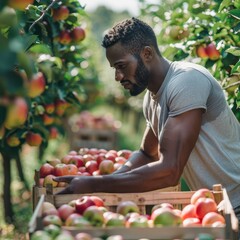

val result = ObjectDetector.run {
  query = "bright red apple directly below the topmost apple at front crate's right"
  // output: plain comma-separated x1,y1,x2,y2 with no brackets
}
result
195,198,217,220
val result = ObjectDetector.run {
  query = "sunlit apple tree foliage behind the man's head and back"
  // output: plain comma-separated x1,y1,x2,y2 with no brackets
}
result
140,0,240,121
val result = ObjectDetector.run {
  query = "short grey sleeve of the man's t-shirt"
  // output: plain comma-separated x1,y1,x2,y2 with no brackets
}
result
167,69,211,117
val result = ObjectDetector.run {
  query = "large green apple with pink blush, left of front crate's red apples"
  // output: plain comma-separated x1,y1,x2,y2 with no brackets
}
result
151,208,182,226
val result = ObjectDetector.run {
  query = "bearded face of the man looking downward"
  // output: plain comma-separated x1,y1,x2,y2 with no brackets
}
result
106,43,150,96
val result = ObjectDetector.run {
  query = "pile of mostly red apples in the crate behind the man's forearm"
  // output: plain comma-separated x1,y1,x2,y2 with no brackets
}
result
37,148,132,187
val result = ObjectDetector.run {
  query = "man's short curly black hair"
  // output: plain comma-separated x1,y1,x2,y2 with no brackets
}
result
102,17,161,55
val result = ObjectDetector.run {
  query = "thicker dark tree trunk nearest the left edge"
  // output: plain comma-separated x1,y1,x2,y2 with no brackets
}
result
2,153,13,223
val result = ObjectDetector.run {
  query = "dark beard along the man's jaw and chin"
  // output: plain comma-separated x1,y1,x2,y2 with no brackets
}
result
129,56,150,96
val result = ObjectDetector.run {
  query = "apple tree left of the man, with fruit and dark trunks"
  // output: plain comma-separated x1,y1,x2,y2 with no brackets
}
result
0,0,98,222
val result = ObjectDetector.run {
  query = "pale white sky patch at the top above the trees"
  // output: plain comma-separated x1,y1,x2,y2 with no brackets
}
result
79,0,159,16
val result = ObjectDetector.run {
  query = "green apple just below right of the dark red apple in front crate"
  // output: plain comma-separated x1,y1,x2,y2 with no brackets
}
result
83,206,104,227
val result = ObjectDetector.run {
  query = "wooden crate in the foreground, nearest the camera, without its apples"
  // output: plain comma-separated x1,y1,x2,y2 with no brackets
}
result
29,185,238,240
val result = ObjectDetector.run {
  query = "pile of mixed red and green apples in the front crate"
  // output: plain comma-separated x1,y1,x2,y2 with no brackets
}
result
31,188,225,240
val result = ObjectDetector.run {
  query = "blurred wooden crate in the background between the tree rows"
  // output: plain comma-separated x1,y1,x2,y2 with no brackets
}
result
70,128,117,150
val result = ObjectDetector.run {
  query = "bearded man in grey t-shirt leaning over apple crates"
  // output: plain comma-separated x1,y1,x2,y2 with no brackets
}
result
56,18,240,221
